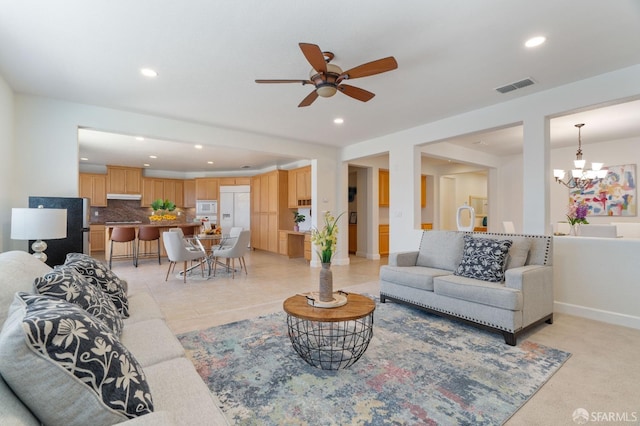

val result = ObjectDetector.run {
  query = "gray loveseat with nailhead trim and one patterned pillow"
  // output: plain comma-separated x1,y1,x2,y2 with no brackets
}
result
380,231,553,346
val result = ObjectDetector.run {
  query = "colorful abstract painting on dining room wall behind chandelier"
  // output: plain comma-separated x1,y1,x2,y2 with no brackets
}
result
569,164,638,216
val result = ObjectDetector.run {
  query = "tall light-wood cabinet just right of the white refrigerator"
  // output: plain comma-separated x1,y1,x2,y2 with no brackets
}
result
251,170,291,253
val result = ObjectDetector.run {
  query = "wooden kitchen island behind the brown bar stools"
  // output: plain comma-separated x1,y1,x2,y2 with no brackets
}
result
104,222,200,262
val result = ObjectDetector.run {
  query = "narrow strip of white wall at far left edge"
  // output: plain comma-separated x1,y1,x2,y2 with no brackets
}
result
0,76,14,252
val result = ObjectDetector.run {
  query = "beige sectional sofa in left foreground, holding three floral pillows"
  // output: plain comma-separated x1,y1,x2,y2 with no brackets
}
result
0,251,228,426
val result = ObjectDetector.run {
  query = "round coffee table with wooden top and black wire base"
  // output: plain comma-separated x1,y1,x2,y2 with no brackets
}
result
282,293,376,370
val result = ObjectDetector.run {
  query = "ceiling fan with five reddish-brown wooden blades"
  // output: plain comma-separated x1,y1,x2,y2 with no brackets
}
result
256,43,398,107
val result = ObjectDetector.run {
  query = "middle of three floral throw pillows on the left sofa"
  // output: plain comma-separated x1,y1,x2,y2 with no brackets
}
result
33,265,123,336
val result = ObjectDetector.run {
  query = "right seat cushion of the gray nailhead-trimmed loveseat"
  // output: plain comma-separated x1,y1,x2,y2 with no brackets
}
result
433,275,523,311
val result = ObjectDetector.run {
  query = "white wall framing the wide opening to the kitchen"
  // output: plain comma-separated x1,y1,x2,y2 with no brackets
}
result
0,94,340,255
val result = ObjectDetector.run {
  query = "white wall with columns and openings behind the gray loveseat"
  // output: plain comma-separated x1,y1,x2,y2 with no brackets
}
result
342,65,640,251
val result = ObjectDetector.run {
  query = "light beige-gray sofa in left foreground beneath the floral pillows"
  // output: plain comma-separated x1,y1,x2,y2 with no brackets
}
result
0,251,228,426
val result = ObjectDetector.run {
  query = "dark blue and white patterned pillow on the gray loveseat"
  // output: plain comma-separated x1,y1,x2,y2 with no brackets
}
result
454,235,513,282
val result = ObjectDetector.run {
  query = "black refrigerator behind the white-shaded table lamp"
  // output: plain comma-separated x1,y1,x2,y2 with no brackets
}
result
29,196,90,266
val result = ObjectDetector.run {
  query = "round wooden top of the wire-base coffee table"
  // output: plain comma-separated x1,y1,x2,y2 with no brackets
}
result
282,293,376,322
